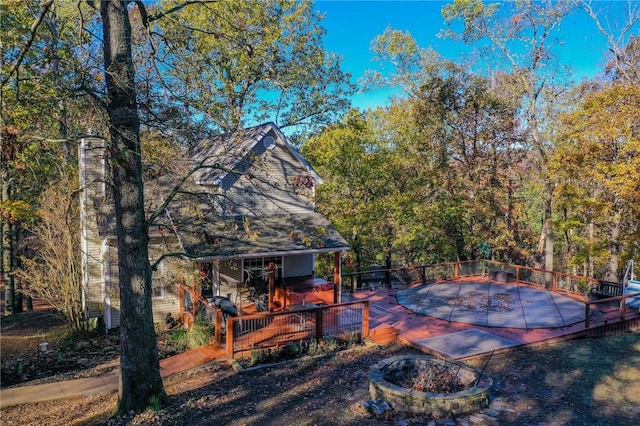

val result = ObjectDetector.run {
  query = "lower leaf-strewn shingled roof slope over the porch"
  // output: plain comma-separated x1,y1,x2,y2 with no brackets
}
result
98,197,350,259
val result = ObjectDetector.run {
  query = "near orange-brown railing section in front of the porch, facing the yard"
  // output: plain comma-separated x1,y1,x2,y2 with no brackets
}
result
222,301,369,358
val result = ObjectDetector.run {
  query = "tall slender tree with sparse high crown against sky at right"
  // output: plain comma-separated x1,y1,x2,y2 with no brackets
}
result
442,0,573,270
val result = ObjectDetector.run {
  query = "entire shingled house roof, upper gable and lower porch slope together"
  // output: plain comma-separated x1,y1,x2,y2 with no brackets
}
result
98,123,349,259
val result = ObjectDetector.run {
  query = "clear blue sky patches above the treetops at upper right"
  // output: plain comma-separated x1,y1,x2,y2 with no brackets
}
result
315,0,638,109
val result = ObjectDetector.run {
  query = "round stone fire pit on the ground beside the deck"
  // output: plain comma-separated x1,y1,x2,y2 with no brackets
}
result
369,355,493,418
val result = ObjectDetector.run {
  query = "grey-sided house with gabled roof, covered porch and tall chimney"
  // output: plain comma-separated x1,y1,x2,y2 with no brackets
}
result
79,123,349,328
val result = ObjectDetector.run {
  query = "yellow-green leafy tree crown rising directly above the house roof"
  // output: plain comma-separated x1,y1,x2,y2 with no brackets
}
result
134,0,354,136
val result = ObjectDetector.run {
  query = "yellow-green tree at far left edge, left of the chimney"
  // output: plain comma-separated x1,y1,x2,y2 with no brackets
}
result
0,1,100,311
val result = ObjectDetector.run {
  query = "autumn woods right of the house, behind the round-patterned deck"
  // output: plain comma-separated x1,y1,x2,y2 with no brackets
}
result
302,38,640,282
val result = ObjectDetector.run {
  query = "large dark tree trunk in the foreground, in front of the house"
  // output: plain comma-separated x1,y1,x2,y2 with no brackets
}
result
100,0,167,413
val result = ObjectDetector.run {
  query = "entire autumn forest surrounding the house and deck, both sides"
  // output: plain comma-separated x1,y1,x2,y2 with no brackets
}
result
0,0,640,322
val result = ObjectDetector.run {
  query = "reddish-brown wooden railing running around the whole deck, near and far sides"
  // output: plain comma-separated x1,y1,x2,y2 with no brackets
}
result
180,260,640,358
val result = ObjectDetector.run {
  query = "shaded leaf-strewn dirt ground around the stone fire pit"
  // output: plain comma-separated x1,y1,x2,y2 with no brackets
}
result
0,302,640,426
